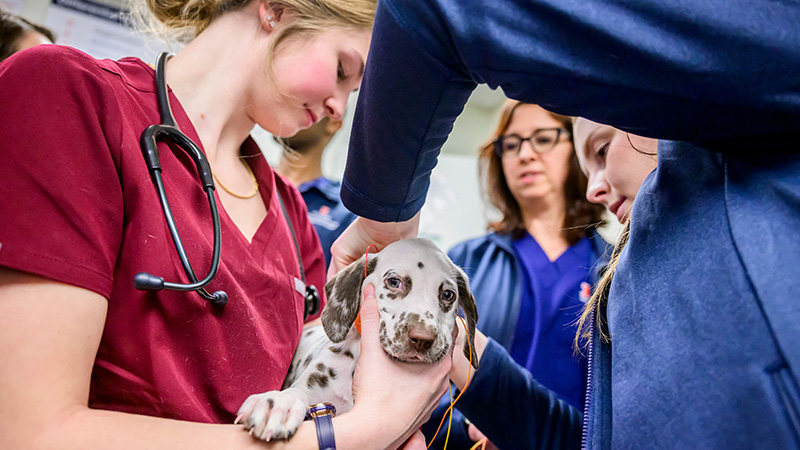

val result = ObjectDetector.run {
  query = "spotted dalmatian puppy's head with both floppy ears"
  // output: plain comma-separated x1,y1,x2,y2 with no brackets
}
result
322,239,478,368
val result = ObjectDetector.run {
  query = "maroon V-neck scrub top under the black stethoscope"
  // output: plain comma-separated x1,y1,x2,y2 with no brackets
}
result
0,45,325,423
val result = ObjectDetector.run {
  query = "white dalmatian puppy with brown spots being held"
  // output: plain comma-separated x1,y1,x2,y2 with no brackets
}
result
236,239,478,441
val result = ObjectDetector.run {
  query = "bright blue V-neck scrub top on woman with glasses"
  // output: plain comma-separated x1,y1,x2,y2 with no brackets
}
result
510,233,593,407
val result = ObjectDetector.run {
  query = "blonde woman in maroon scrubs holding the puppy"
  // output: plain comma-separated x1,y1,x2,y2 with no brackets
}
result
0,0,450,449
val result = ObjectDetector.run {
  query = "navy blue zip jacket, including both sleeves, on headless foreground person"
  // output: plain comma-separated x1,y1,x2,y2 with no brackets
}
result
342,0,800,449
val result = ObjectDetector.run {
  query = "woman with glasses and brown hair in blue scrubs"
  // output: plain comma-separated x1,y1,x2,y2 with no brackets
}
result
423,100,610,448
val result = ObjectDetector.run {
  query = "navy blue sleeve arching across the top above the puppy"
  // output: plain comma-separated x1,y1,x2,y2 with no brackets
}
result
342,0,800,221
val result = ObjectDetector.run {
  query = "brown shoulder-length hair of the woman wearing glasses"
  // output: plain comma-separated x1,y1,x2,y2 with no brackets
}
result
479,100,605,245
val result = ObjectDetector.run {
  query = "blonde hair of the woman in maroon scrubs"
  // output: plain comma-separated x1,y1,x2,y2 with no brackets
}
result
131,0,378,47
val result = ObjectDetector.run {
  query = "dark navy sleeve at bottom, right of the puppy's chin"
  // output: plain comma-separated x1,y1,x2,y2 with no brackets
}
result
457,339,582,450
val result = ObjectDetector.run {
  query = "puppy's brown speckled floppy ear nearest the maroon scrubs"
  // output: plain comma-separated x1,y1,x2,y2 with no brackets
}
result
320,255,378,342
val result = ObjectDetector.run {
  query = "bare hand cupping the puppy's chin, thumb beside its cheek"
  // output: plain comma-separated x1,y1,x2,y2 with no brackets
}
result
351,284,451,449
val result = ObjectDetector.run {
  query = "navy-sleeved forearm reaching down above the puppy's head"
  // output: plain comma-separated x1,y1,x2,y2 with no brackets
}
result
341,2,476,222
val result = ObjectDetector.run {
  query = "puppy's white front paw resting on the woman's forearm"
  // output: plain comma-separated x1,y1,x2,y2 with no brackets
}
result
235,389,308,442
